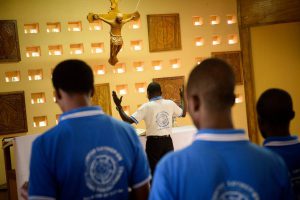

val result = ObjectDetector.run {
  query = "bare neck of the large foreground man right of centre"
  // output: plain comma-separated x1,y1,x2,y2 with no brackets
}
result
198,109,234,129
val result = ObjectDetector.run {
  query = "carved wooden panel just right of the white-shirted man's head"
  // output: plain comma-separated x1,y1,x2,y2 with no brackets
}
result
153,76,184,105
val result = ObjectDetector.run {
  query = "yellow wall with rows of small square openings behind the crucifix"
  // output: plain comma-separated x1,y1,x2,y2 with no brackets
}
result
0,0,247,184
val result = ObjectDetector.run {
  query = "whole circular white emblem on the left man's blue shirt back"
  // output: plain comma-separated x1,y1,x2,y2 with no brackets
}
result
85,147,124,192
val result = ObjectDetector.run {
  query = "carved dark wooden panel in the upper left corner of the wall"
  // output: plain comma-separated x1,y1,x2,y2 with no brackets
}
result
0,20,21,62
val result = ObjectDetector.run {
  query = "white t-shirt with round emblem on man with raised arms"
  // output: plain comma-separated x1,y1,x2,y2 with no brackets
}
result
131,97,183,136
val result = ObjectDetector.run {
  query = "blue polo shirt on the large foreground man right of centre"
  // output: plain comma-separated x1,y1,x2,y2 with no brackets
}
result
150,129,292,200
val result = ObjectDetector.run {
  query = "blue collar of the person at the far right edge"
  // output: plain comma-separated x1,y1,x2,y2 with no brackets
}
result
263,136,299,146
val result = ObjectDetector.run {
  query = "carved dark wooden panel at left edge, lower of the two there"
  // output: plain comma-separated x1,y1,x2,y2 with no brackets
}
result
0,92,28,134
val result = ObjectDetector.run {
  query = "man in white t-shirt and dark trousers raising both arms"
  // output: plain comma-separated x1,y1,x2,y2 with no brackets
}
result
112,82,186,174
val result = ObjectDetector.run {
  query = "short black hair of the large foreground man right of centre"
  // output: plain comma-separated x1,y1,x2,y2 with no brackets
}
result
187,58,235,111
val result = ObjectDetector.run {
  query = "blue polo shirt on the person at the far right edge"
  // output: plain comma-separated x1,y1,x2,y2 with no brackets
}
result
264,136,300,199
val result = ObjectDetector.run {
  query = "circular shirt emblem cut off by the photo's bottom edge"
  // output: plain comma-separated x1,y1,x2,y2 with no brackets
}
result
212,181,259,200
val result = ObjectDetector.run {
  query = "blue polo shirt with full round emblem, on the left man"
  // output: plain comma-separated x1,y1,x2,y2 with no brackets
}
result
29,107,150,200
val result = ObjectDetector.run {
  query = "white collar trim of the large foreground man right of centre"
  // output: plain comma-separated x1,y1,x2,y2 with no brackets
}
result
194,133,248,142
